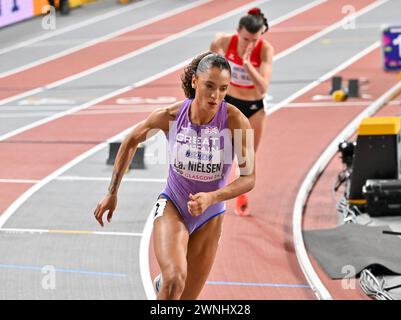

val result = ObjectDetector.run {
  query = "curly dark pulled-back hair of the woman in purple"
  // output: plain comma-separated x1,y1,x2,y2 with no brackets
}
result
181,51,231,99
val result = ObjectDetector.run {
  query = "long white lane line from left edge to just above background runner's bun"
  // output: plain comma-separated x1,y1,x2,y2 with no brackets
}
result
0,0,271,106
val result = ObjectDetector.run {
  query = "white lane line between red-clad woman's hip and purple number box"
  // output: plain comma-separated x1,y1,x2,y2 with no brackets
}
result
266,42,387,115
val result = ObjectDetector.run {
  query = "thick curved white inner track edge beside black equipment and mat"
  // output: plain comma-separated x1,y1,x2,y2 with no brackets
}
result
292,82,401,300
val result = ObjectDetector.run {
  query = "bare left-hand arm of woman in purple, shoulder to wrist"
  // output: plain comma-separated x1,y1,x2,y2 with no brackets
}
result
108,108,169,195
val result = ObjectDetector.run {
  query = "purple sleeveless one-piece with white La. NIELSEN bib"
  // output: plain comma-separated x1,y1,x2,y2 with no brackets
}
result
161,99,233,234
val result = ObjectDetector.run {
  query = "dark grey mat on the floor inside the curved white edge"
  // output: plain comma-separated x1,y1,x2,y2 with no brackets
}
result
303,224,401,279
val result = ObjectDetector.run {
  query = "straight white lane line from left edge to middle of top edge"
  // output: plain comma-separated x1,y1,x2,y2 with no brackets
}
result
0,0,211,79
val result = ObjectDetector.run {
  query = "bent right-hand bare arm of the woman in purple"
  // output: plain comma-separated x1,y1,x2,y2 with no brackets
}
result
208,111,255,203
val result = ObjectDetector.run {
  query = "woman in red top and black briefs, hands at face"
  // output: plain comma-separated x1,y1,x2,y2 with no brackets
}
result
210,8,274,216
